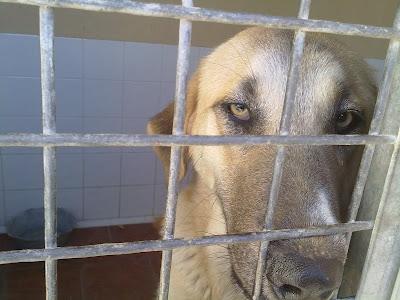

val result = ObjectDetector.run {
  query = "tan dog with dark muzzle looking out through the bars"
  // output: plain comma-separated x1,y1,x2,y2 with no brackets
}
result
148,27,377,300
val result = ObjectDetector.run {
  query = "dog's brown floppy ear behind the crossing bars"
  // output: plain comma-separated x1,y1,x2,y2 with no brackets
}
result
147,74,198,180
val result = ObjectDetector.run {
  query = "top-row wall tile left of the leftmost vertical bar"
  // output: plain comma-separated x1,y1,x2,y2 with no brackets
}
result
0,33,40,77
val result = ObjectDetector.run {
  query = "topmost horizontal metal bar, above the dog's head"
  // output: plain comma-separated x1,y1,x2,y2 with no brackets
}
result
0,0,400,39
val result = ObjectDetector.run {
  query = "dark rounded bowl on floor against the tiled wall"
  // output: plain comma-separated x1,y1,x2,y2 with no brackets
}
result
6,208,76,249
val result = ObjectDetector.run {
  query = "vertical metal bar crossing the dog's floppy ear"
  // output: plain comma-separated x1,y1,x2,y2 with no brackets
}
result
158,0,193,300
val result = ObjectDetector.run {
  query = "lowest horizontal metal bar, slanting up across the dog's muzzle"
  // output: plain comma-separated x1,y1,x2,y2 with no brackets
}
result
0,221,373,264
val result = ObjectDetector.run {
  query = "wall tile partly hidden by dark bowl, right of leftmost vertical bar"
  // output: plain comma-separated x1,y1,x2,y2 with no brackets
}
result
57,188,83,221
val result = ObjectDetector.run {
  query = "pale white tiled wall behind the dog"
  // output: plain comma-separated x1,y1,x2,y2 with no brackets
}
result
0,34,210,231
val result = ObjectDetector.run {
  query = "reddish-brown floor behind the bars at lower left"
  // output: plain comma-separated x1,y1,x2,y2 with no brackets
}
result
0,224,161,300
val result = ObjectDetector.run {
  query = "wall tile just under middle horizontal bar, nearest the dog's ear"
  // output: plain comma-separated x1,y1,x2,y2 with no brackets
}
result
121,153,155,185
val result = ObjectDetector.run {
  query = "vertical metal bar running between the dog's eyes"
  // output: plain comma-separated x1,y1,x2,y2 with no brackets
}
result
253,0,311,300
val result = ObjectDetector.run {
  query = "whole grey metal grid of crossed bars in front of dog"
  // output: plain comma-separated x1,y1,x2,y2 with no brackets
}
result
0,0,400,300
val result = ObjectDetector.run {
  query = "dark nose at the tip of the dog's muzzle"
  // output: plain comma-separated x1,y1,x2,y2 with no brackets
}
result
268,255,341,300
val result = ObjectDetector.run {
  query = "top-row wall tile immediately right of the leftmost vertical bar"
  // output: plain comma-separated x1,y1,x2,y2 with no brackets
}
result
54,37,83,78
